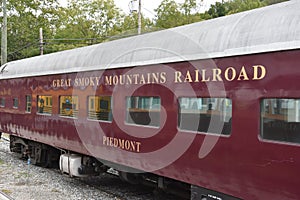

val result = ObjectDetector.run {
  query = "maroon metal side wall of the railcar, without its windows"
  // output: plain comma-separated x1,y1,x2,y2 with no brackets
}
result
0,51,300,199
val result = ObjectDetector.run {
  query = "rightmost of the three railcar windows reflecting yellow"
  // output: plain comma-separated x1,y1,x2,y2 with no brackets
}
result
88,96,112,122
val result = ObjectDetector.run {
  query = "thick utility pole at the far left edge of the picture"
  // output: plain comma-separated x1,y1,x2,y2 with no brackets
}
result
1,0,7,65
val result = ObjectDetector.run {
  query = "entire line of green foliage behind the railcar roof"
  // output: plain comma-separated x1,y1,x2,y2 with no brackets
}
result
0,0,284,61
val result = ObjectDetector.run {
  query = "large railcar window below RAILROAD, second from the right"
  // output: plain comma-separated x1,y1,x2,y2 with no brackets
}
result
178,97,232,135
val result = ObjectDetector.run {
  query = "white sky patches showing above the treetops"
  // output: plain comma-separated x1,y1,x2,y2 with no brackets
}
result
59,0,222,18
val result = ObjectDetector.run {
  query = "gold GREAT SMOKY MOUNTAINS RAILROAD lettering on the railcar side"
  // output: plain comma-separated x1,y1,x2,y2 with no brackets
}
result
51,65,267,88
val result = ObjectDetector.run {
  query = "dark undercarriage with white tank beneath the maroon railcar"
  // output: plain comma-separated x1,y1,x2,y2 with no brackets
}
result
10,135,191,199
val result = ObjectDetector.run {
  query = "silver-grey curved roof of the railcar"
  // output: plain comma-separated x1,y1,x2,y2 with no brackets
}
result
0,0,300,79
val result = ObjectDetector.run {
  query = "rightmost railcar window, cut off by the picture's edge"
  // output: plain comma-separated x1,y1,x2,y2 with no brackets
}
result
260,98,300,144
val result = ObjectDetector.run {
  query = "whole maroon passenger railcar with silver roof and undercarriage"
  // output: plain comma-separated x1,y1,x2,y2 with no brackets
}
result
0,1,300,199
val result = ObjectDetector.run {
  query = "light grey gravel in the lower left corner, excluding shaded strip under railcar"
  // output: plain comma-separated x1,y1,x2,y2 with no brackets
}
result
0,137,115,200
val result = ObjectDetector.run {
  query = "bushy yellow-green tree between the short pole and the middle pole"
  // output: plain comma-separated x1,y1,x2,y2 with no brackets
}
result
55,0,122,48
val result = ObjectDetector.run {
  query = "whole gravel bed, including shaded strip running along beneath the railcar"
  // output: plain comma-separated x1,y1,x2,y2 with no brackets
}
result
0,135,183,200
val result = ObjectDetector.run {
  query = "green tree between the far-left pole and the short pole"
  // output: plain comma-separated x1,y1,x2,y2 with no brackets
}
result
1,0,58,61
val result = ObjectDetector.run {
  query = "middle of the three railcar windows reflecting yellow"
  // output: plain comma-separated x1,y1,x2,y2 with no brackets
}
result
59,96,79,117
